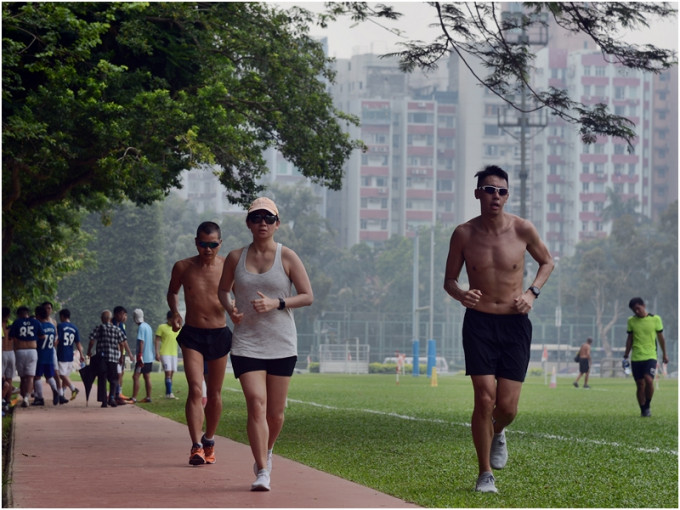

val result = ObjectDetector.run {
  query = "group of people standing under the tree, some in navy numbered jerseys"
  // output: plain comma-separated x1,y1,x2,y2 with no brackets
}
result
2,302,183,412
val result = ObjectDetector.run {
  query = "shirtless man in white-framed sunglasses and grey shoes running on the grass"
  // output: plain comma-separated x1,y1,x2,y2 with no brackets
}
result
444,166,554,492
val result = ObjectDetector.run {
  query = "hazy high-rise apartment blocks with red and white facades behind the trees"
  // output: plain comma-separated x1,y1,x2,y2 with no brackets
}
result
178,27,678,256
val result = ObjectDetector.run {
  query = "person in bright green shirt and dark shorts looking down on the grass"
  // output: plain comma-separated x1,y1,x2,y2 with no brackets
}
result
623,297,668,418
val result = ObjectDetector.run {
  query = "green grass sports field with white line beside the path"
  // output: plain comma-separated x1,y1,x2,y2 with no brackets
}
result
117,373,678,508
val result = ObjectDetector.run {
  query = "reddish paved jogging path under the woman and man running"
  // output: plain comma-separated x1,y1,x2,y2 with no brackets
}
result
8,382,416,508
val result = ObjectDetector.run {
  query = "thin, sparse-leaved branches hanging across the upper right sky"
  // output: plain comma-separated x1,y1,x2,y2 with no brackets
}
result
327,2,677,150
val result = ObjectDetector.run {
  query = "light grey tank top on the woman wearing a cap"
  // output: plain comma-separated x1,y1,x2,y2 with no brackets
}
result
231,243,297,359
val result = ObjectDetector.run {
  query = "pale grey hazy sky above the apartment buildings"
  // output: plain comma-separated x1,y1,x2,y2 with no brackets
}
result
276,1,678,58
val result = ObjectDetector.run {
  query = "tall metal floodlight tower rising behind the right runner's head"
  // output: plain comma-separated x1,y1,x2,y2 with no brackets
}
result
498,11,548,218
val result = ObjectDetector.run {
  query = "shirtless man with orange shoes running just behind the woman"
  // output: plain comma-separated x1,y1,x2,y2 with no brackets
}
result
168,221,231,465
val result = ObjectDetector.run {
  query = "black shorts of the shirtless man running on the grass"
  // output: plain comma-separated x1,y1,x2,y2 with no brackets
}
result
463,308,532,382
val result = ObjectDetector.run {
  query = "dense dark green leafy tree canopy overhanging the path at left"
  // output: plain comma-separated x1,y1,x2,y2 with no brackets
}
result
2,2,363,304
